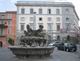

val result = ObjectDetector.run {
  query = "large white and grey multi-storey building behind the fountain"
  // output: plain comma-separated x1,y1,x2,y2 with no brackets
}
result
16,1,79,40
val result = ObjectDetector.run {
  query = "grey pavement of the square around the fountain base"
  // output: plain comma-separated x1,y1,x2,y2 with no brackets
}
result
0,48,80,61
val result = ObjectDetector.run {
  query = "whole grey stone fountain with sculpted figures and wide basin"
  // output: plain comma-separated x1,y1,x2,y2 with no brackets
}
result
9,25,54,57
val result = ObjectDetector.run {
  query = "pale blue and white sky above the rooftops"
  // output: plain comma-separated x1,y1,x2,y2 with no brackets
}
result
0,0,80,26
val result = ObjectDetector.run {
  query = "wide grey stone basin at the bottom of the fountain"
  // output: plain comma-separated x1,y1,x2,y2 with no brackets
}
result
9,46,54,56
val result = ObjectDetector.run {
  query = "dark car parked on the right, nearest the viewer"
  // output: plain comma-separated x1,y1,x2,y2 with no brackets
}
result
57,43,77,52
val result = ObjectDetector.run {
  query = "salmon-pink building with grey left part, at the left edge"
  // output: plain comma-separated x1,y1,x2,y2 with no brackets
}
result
0,11,16,47
